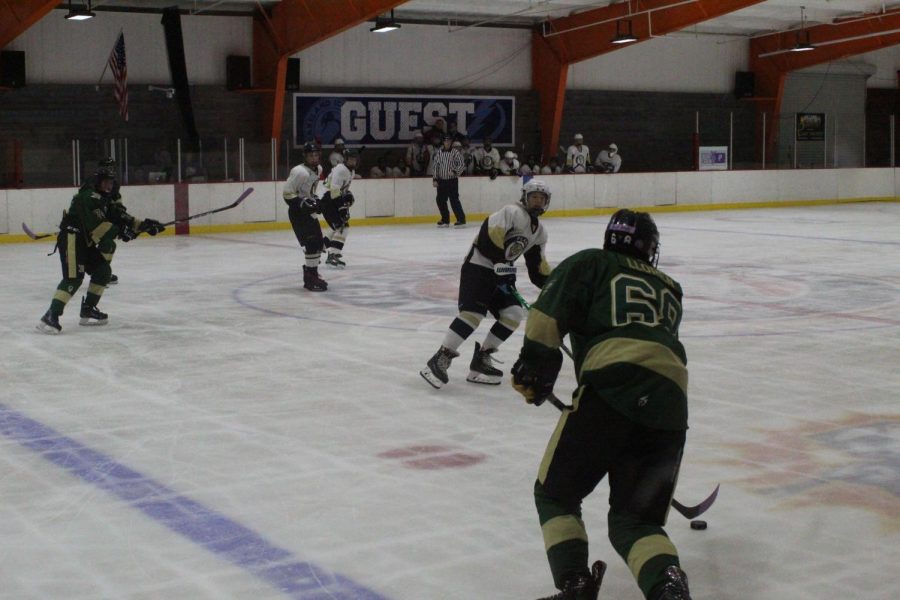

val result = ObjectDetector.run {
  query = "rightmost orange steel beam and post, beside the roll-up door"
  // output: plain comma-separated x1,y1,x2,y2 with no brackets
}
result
750,9,900,164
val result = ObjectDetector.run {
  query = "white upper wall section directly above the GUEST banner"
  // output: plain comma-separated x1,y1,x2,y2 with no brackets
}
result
296,23,531,91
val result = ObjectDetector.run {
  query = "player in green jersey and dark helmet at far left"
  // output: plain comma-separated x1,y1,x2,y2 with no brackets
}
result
37,159,165,334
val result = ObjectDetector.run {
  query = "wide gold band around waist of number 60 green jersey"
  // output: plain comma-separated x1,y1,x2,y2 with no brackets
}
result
576,340,688,396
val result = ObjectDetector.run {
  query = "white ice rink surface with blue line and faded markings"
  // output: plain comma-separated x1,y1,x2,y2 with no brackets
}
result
0,203,900,600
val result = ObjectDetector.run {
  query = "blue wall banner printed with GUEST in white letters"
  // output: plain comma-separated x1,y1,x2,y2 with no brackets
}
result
294,94,516,148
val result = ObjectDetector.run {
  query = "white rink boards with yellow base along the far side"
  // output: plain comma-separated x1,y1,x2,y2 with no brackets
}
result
0,168,900,242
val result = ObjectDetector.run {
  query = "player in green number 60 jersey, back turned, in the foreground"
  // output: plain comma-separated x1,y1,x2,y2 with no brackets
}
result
512,209,690,600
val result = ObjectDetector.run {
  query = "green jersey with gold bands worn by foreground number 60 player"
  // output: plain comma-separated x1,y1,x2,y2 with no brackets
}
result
522,249,688,430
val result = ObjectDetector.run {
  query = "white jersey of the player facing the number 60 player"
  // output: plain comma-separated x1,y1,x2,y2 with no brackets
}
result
466,204,550,287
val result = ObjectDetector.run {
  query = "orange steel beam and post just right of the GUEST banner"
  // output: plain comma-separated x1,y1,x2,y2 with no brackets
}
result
532,0,764,162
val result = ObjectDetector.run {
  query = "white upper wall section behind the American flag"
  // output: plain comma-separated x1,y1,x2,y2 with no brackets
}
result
4,10,253,85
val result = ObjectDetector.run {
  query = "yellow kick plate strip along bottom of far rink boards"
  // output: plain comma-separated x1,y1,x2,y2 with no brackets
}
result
0,196,900,244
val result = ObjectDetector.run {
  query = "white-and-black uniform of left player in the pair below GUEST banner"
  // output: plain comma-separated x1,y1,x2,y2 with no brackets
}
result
282,164,323,268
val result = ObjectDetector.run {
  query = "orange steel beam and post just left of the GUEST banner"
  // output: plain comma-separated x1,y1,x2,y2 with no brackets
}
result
255,0,406,138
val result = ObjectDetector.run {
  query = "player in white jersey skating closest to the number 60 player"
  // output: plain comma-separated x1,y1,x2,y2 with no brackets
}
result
419,179,550,389
